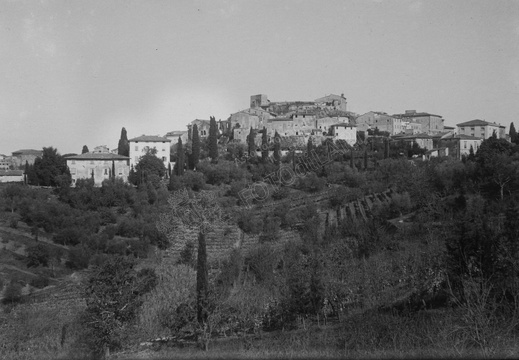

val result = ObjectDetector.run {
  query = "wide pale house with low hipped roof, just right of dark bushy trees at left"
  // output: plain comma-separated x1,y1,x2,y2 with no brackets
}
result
66,146,130,186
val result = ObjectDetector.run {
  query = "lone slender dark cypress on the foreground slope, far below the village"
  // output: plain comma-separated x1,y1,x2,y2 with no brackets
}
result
196,231,209,325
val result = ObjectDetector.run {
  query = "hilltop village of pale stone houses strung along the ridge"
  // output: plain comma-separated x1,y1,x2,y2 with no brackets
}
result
0,94,507,185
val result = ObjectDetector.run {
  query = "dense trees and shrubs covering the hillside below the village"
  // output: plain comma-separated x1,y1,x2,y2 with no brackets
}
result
0,134,519,356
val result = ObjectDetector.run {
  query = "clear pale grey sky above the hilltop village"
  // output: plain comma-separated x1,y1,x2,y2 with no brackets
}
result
0,0,519,155
